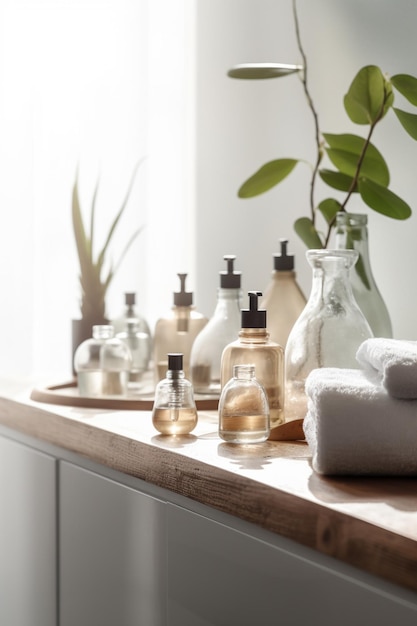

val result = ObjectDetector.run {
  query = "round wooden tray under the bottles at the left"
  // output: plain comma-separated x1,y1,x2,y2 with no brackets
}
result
30,380,219,411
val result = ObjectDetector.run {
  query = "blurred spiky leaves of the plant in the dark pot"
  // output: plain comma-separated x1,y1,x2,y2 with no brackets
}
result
72,160,143,321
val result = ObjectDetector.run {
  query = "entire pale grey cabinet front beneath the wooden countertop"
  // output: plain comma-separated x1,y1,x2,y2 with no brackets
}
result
0,428,417,626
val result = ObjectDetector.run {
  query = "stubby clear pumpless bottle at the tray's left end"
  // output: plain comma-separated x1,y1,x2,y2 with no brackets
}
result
74,325,132,397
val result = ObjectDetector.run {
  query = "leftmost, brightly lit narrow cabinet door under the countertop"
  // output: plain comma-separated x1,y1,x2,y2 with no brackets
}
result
0,437,57,626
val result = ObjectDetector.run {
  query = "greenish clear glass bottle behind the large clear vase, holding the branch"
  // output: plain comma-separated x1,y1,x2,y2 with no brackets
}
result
335,211,392,338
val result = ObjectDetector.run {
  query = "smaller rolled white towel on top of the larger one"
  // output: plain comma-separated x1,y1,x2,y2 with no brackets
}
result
356,337,417,399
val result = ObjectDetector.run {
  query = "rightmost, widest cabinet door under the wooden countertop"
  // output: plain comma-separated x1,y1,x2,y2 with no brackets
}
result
167,505,417,626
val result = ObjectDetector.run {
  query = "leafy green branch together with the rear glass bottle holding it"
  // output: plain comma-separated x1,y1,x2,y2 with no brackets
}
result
228,0,417,336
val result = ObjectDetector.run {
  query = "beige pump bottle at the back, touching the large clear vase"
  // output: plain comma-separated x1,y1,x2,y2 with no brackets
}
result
260,239,307,349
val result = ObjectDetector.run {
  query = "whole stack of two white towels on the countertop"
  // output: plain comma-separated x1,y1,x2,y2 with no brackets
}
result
304,338,417,476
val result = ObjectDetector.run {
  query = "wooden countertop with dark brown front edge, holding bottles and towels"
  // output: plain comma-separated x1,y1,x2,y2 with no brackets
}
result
0,380,417,591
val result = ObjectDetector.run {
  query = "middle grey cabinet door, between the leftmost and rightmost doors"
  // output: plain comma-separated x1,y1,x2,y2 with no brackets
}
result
59,462,166,626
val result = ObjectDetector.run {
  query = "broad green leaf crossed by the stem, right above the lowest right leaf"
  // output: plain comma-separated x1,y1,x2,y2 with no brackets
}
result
323,133,390,187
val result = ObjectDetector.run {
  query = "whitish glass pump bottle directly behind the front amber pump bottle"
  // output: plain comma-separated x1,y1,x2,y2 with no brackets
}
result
190,254,242,395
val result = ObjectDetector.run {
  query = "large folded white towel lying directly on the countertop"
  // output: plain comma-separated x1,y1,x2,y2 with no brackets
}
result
304,368,417,476
